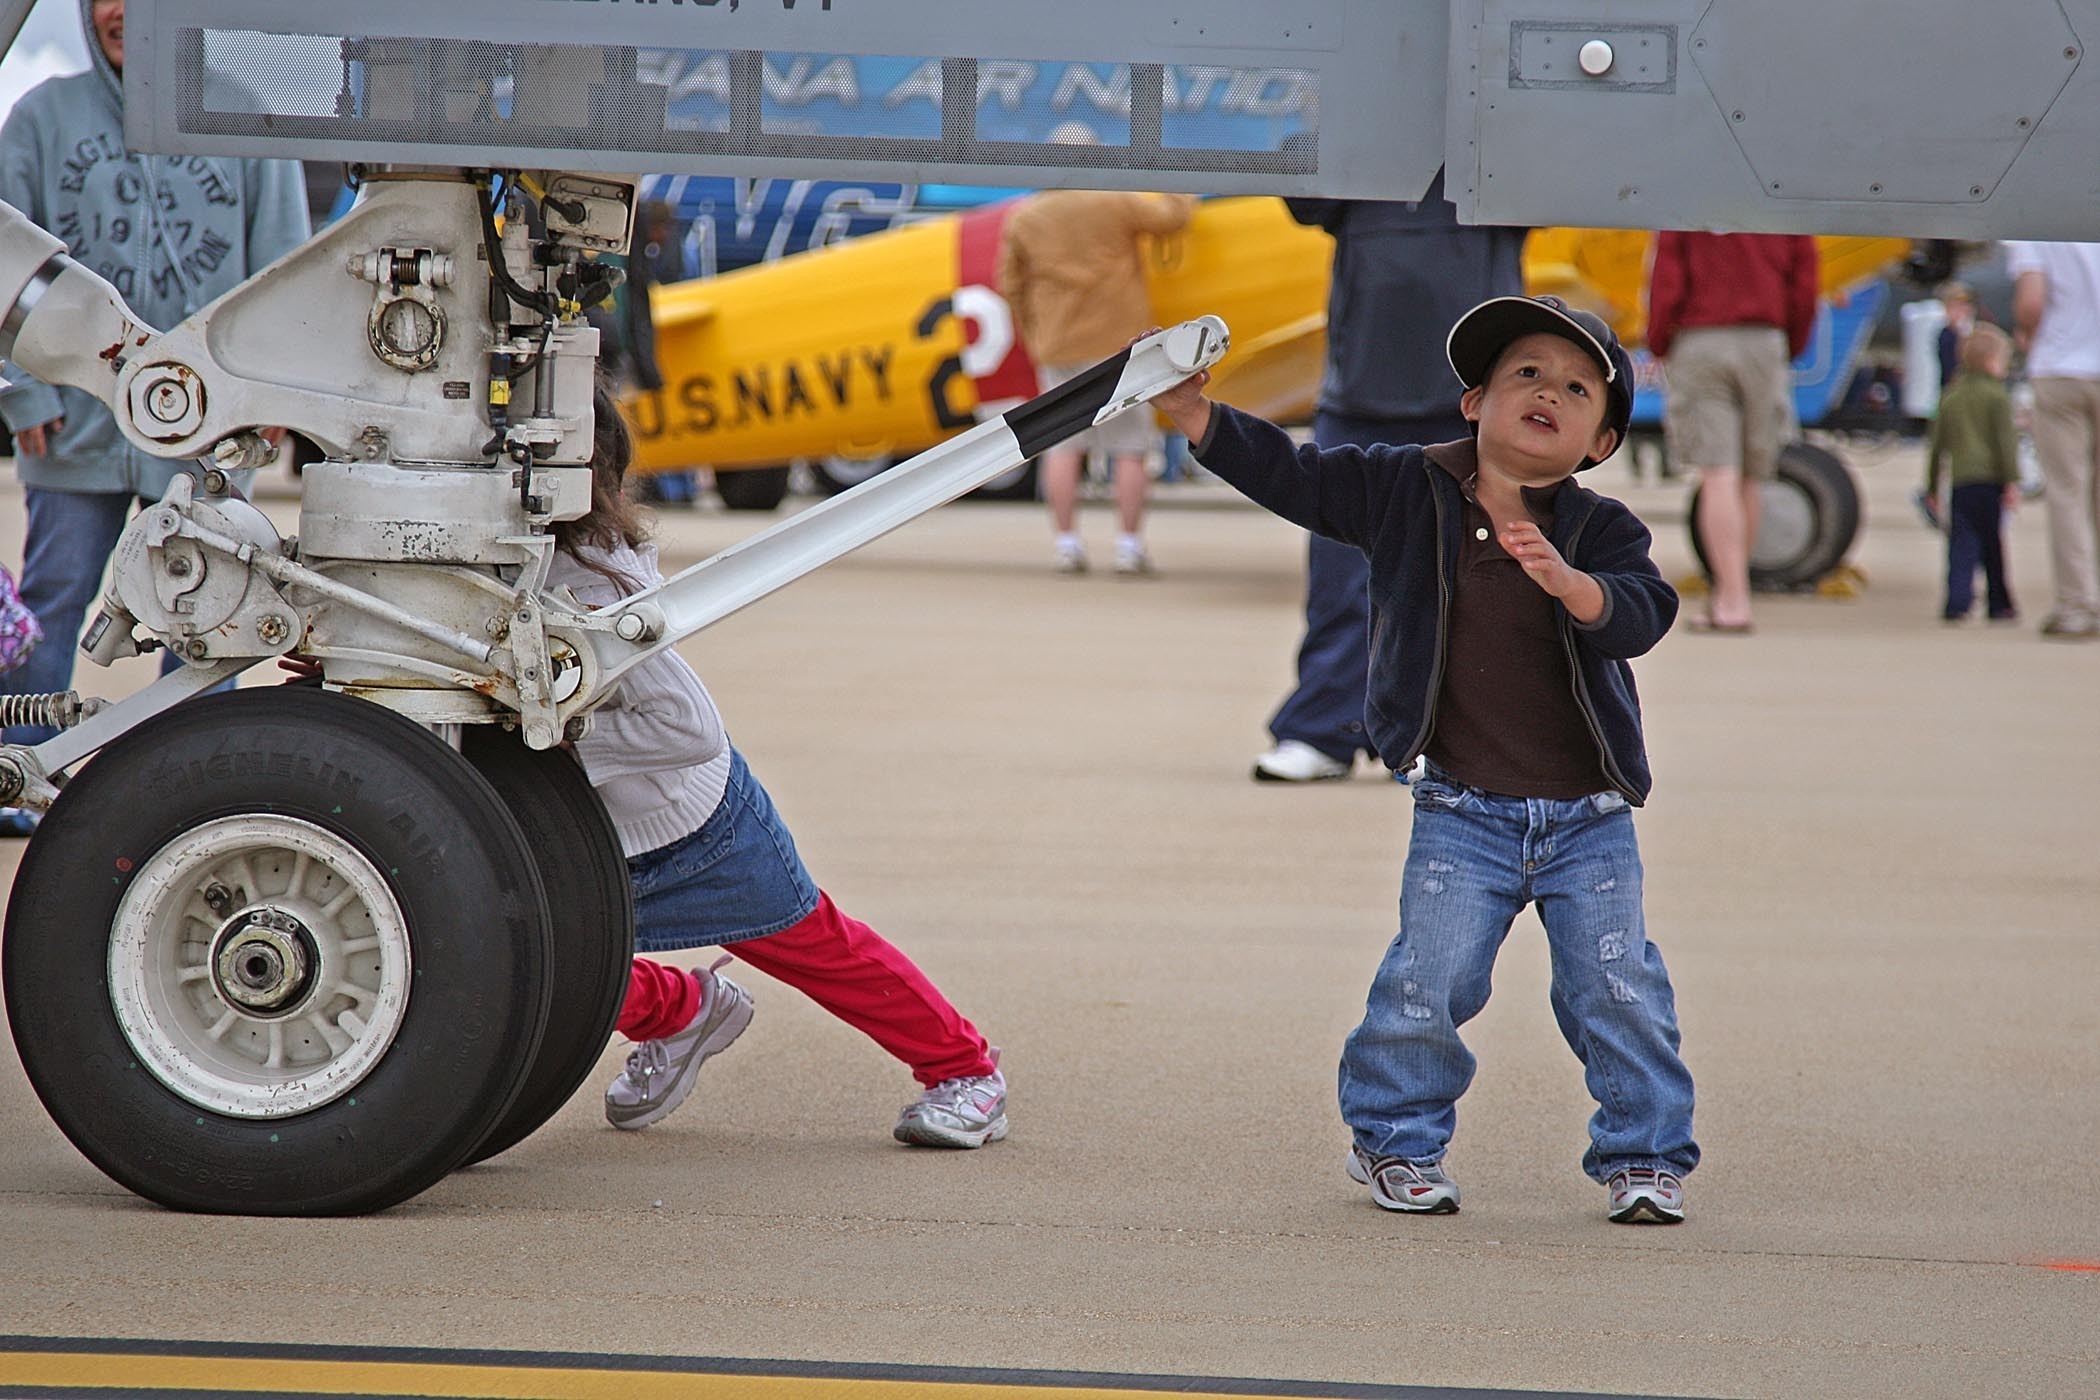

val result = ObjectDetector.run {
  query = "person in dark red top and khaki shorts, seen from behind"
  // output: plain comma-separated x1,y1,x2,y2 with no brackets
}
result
1649,233,1817,634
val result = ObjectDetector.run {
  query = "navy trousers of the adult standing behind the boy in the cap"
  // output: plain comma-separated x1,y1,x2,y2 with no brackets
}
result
1268,413,1466,764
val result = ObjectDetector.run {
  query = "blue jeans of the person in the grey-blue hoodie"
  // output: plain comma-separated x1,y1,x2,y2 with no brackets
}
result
0,487,181,743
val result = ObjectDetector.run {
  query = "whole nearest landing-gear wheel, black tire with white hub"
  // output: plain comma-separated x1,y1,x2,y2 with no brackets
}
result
0,686,550,1215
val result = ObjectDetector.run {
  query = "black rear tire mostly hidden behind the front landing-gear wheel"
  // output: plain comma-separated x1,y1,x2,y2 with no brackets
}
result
460,724,634,1165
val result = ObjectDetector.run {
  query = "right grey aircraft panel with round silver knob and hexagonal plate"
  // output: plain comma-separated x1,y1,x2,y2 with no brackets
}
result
1447,0,2100,239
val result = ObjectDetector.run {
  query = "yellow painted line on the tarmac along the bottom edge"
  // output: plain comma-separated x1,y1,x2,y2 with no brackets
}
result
0,1352,1310,1400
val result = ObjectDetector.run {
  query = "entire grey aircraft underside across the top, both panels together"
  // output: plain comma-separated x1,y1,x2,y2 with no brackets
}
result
126,0,2100,237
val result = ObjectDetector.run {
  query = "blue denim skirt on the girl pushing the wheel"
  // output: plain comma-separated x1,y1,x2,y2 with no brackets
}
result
628,751,817,953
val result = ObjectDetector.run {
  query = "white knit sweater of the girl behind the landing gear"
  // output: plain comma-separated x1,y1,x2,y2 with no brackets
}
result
548,544,729,856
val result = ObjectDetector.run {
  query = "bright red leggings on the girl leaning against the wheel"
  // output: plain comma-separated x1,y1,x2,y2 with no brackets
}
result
620,892,993,1087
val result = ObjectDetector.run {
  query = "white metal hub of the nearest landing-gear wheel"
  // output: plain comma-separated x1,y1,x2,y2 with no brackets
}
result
109,814,412,1119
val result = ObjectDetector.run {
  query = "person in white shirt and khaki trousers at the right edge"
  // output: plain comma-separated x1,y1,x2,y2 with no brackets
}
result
2006,243,2100,642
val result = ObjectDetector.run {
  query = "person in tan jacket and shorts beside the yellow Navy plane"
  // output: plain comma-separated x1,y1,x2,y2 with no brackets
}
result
1000,189,1195,575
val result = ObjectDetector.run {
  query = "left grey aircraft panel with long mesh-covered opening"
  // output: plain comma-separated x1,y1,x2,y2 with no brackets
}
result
126,0,1447,197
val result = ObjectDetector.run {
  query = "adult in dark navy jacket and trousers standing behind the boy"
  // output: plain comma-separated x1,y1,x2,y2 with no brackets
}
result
1254,174,1527,783
